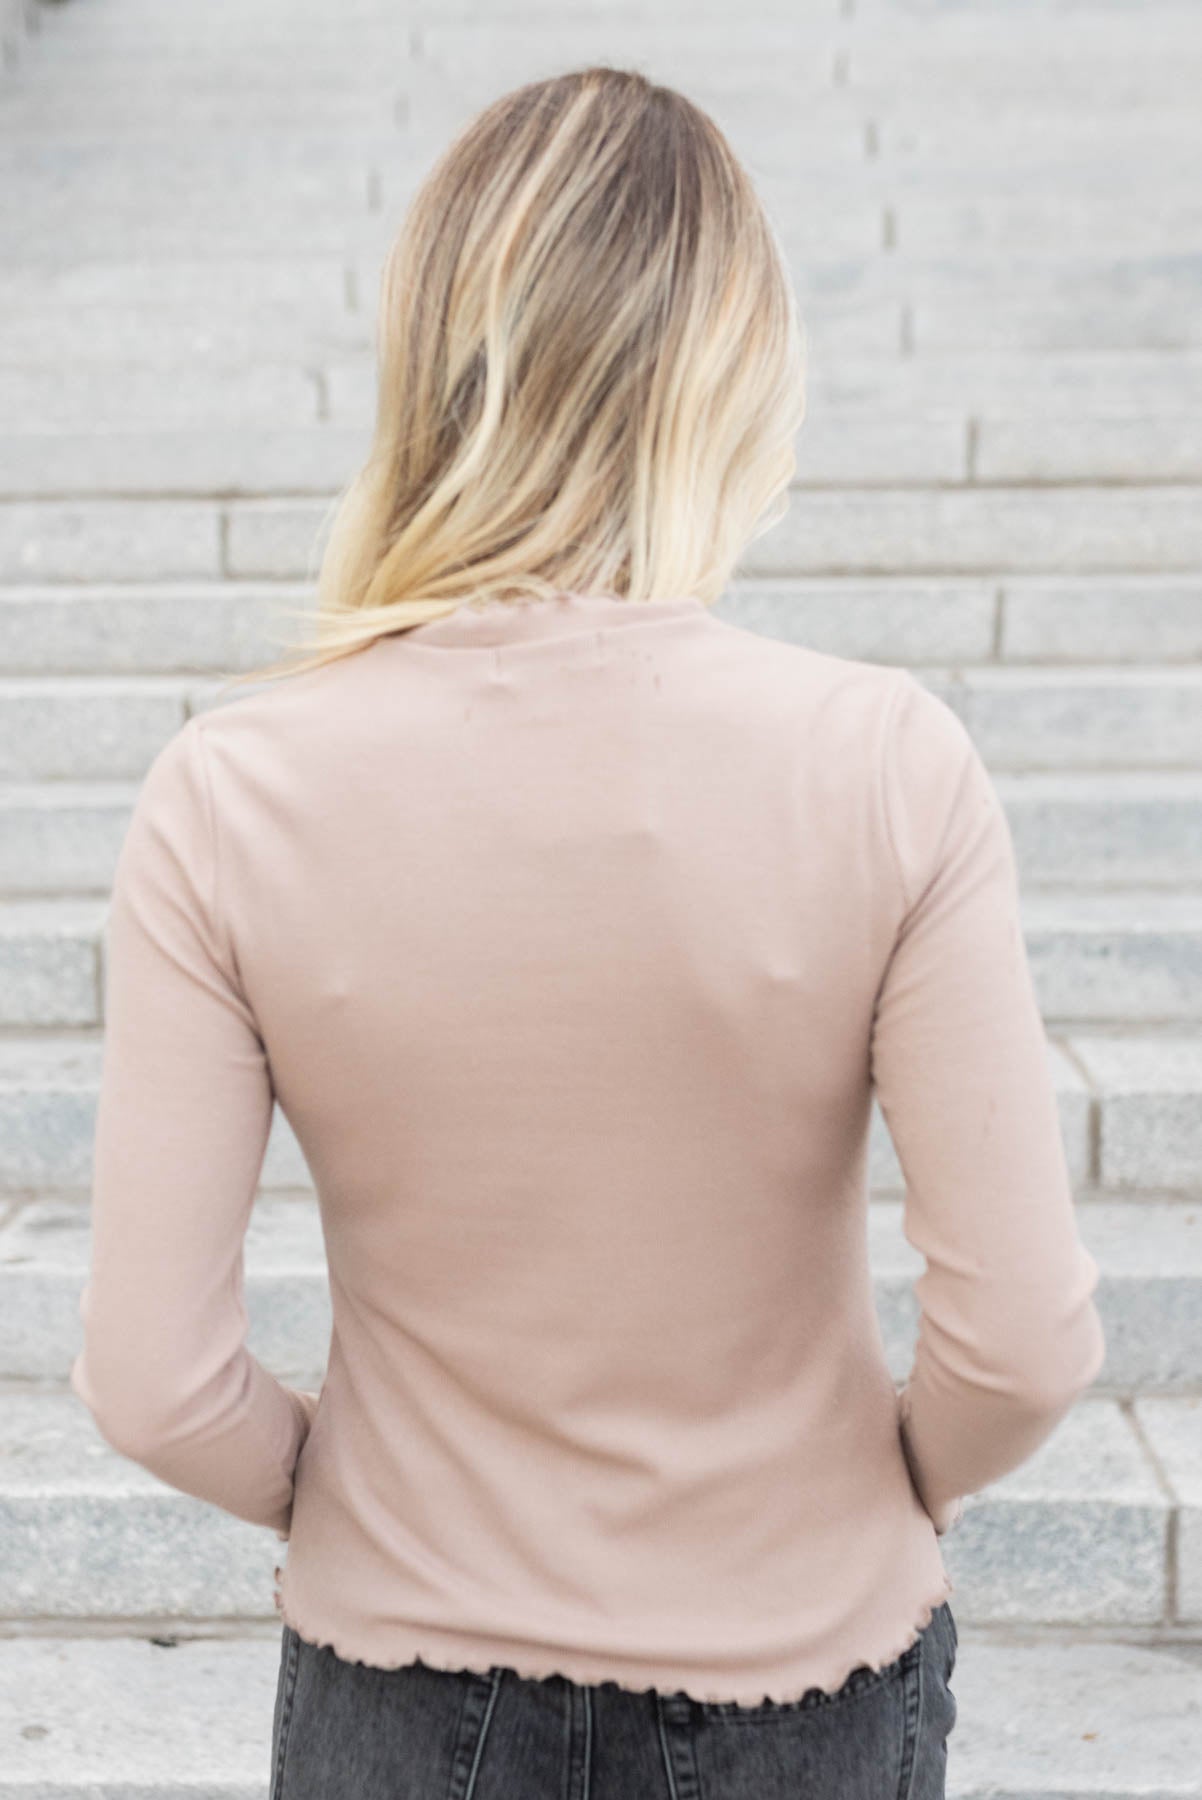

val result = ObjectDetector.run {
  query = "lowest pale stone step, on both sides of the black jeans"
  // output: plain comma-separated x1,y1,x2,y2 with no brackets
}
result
0,1634,1202,1800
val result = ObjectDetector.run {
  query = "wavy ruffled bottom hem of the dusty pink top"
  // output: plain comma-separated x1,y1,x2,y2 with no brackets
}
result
275,1568,955,1710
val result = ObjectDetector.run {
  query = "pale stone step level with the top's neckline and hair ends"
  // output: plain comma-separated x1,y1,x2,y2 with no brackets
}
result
0,576,1202,679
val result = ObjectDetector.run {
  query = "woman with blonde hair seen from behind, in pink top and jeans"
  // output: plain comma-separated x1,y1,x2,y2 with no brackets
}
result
72,68,1103,1800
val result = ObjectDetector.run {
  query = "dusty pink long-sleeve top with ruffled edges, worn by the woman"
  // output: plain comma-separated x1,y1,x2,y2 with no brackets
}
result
70,594,1105,1703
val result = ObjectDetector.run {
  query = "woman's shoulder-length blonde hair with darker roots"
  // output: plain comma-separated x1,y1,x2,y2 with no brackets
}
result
224,67,804,680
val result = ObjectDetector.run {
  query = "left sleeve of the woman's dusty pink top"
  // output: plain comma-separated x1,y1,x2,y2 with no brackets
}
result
70,716,315,1537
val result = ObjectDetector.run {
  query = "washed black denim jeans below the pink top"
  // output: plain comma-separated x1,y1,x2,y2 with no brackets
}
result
270,1600,957,1800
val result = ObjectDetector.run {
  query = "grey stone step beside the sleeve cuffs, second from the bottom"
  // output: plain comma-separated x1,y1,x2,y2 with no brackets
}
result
0,1388,1202,1631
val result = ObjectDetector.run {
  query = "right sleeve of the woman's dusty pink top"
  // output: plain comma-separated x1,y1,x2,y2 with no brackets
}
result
873,670,1105,1534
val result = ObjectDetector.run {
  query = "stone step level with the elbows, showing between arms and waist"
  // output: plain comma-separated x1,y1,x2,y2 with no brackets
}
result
0,1188,1202,1399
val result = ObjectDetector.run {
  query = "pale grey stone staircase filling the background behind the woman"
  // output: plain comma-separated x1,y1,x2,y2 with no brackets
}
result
0,0,1202,1800
